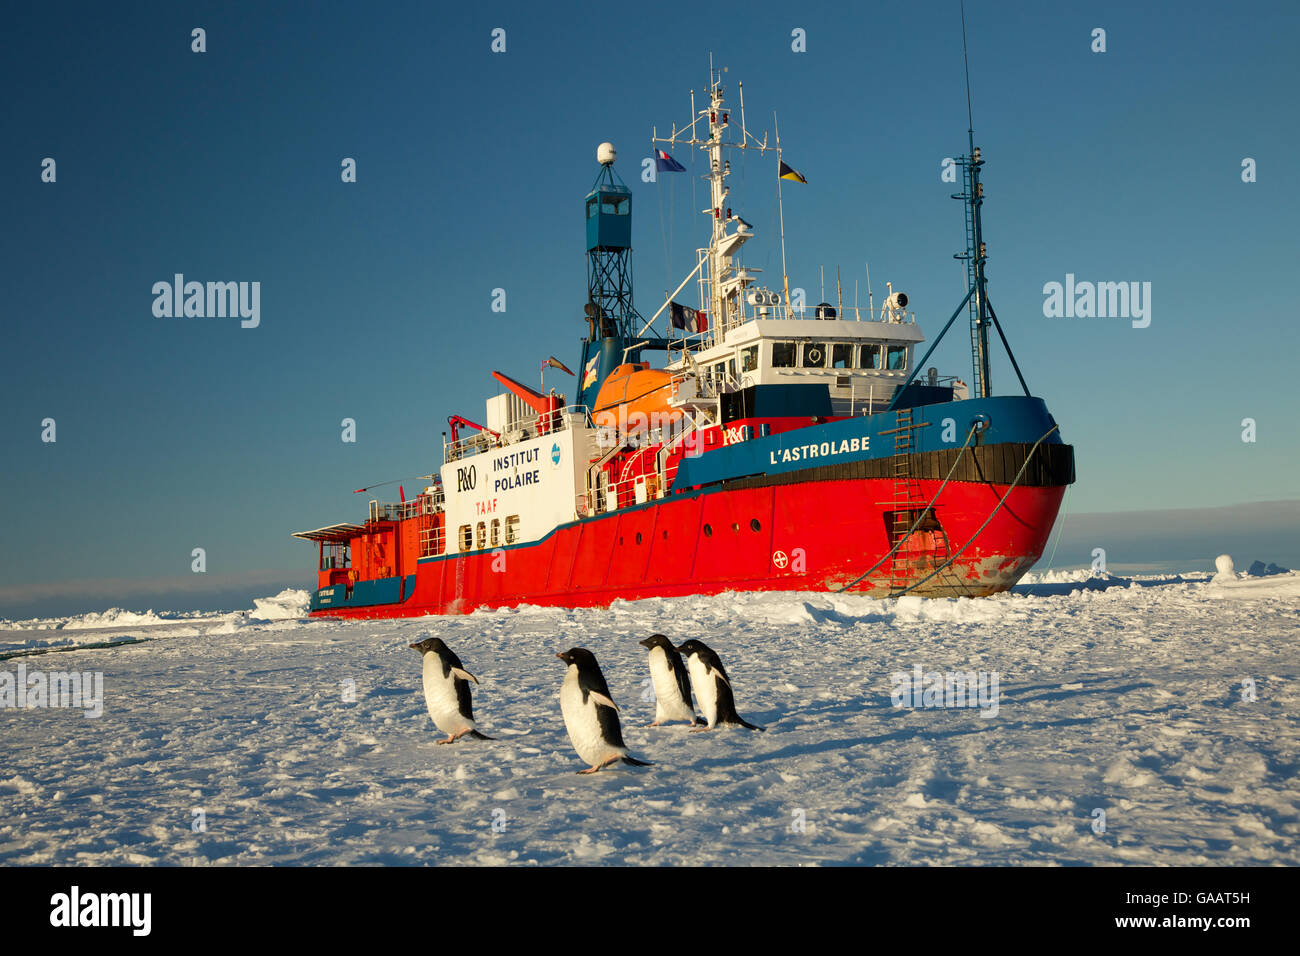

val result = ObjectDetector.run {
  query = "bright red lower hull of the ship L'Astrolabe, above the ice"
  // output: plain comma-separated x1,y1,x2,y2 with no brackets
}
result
313,479,1065,619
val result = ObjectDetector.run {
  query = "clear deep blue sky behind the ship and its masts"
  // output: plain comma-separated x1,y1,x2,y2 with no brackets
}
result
0,3,1300,617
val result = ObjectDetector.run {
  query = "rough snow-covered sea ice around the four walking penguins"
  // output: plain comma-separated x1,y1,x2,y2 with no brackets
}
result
0,572,1300,865
